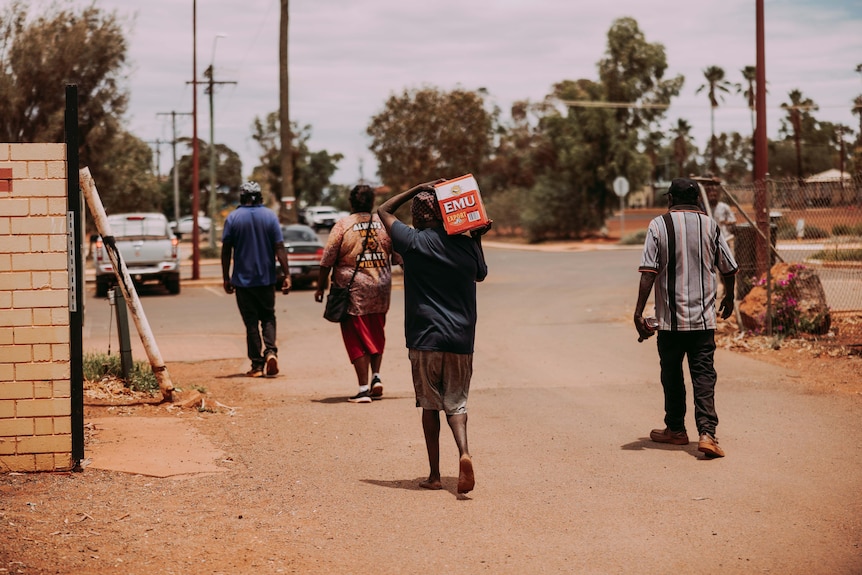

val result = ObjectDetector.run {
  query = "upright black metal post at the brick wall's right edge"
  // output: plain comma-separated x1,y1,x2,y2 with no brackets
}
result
64,84,84,471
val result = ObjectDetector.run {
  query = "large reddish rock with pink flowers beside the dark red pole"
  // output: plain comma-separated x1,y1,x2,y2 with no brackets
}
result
739,263,831,335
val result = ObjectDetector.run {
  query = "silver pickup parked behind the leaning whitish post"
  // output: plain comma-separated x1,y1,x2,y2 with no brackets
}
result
93,213,180,297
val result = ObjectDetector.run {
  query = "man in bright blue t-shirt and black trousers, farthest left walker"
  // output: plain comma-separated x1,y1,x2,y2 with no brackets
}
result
221,182,290,377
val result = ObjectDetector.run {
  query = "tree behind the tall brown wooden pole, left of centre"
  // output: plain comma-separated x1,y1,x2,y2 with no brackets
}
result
252,112,344,213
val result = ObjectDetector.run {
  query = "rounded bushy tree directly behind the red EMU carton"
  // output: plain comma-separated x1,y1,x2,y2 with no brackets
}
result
366,87,499,194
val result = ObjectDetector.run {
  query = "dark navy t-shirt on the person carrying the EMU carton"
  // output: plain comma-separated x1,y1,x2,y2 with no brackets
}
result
392,221,488,354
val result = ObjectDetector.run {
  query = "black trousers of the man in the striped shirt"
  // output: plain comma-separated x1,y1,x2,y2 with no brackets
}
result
657,330,718,436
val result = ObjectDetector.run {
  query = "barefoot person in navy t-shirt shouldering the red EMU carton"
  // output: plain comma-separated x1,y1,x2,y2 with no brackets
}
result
377,180,491,493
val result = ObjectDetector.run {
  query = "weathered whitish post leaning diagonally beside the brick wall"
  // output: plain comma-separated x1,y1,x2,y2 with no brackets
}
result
79,164,174,401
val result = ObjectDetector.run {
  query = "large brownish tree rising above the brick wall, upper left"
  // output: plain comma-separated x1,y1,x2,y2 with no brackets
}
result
0,0,133,198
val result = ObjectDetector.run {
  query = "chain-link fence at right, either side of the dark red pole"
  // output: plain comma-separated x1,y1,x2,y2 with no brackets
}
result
724,176,862,346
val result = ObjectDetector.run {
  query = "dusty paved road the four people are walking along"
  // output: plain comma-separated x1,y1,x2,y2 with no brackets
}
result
85,245,862,574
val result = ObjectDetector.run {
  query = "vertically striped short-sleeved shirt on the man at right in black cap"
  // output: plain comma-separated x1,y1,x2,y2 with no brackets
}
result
638,205,738,331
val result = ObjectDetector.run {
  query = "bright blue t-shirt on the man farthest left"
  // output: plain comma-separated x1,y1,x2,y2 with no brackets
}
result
221,206,284,288
